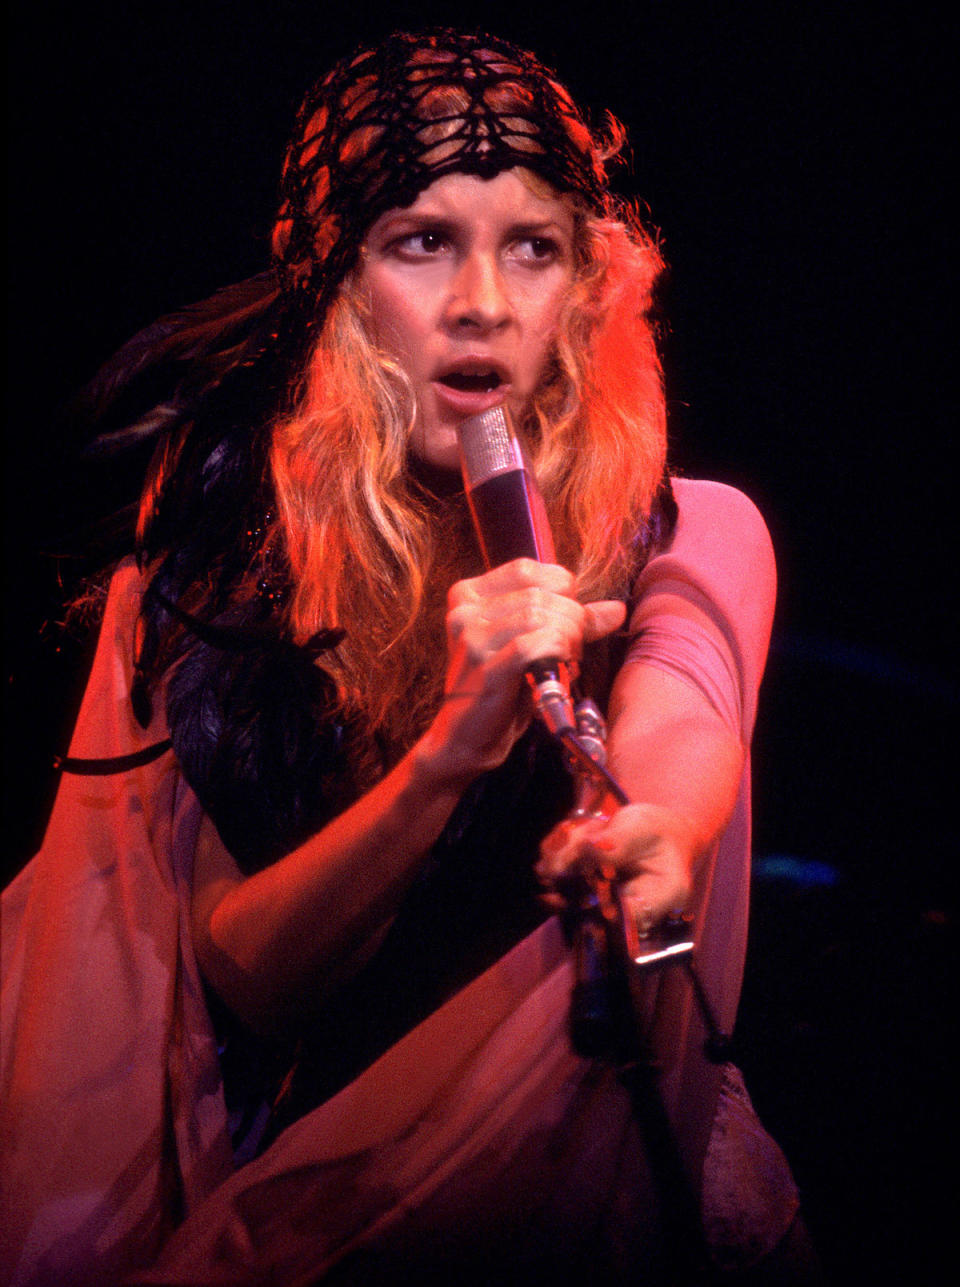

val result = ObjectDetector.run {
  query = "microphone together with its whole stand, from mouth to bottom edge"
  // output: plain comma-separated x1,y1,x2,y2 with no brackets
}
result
447,404,728,1283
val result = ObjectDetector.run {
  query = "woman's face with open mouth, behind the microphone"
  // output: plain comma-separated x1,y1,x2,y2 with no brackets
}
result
360,170,574,470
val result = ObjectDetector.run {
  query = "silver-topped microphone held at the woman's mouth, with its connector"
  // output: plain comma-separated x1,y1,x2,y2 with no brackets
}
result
457,404,575,737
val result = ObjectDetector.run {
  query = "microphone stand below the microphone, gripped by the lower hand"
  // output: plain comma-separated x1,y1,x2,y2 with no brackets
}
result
556,701,730,1284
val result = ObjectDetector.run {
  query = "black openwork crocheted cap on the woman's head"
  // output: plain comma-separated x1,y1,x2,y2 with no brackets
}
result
268,30,623,334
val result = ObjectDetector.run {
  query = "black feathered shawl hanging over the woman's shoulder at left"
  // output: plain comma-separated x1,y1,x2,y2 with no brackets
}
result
63,273,676,873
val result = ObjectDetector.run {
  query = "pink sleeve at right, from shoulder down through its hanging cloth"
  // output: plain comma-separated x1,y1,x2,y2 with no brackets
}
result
628,479,776,1156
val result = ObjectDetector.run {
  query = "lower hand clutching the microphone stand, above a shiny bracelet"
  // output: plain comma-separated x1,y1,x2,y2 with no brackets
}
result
537,804,703,933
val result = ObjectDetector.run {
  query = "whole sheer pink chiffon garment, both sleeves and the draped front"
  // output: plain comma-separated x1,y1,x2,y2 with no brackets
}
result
0,480,797,1287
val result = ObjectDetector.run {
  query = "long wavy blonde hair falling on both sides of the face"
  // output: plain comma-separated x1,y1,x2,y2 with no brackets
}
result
270,196,667,758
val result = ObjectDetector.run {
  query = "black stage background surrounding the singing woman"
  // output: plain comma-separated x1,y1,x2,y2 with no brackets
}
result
4,0,957,1283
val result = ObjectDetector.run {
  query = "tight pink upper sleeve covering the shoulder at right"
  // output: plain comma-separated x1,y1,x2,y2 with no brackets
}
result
628,479,776,745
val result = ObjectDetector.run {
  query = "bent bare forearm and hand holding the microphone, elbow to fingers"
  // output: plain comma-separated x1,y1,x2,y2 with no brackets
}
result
192,560,624,1027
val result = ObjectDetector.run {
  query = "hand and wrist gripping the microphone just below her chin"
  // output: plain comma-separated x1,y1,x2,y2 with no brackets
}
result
423,559,627,784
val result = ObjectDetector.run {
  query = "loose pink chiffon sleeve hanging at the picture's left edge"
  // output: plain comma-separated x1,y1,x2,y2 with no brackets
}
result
0,562,232,1287
